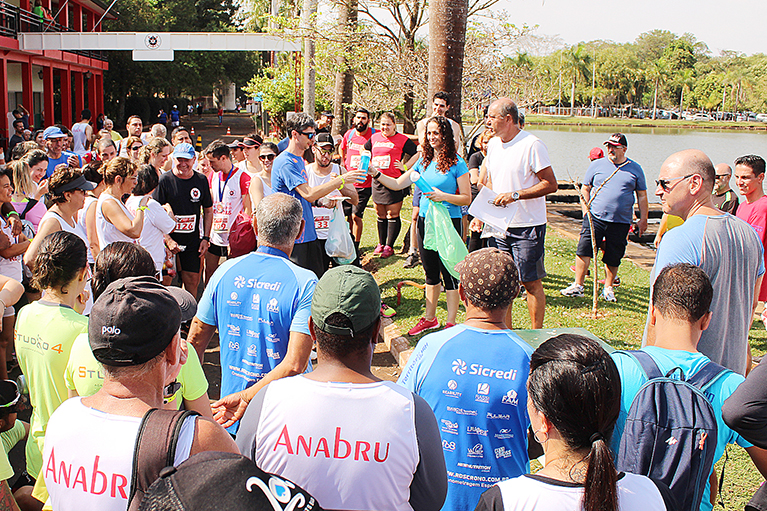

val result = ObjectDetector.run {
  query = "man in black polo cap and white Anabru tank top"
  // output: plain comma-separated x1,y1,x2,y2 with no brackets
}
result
42,277,236,510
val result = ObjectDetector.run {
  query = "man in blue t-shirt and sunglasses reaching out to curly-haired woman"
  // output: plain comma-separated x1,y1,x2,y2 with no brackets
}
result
272,112,364,278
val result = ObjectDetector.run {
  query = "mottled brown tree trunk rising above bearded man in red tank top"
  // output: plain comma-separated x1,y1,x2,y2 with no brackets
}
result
332,0,357,135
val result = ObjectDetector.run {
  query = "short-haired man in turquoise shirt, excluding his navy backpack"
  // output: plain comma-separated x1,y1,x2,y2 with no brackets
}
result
612,263,767,511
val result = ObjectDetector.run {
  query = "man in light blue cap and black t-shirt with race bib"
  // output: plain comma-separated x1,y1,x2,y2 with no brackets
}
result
153,142,213,297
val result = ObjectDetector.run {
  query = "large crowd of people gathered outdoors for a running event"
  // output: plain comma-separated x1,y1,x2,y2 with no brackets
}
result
0,98,767,511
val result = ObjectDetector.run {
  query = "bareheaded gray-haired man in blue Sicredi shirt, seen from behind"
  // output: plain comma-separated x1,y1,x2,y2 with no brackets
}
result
189,193,317,433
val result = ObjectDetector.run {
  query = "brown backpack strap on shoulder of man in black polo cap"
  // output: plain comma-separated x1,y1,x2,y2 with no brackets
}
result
128,408,200,511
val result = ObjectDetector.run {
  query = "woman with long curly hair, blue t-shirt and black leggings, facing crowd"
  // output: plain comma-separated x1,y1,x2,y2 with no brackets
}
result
371,117,471,335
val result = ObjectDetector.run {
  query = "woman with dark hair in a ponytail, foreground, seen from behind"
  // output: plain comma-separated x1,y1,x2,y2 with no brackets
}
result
476,334,675,511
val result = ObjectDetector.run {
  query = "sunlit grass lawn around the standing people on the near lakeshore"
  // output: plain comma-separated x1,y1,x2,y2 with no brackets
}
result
361,197,767,509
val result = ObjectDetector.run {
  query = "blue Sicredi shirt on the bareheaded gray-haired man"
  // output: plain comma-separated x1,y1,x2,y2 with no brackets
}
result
197,247,317,433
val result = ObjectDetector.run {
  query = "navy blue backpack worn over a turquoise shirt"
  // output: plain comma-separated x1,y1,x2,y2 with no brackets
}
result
615,351,729,511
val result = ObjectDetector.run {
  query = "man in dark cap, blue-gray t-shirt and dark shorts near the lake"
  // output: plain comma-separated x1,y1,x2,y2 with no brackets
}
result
561,133,648,302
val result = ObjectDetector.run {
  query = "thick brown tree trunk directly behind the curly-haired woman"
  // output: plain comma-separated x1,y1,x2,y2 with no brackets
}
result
428,0,469,124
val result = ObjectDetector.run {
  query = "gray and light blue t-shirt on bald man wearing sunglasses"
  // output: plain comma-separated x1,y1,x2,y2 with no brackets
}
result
642,214,764,374
